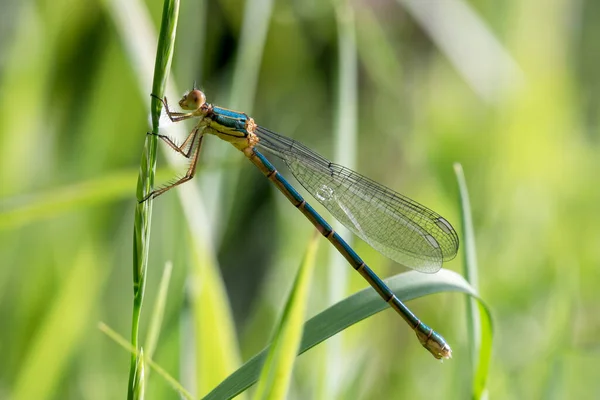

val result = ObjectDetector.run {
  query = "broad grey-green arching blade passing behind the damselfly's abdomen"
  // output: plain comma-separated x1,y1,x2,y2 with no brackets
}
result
204,269,487,400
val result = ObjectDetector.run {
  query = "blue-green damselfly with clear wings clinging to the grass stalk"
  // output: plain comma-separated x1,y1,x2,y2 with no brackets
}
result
142,88,458,359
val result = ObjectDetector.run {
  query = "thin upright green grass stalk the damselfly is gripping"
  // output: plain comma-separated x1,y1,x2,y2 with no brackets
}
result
127,0,179,399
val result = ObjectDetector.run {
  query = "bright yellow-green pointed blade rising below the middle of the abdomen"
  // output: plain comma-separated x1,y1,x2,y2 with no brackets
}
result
254,231,320,400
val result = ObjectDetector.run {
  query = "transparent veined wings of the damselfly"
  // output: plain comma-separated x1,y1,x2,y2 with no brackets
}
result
256,127,458,272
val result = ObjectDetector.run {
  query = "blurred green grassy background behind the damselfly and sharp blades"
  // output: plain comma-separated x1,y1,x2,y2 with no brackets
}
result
0,0,600,399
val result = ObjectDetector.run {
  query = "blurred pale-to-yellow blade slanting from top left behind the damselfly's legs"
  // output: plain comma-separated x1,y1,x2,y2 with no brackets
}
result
105,0,241,393
